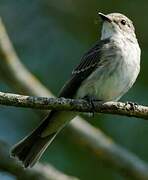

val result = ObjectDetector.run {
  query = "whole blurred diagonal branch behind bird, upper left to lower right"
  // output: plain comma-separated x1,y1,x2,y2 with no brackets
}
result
0,16,148,180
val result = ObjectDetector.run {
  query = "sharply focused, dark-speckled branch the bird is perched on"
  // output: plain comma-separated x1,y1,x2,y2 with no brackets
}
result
0,92,148,119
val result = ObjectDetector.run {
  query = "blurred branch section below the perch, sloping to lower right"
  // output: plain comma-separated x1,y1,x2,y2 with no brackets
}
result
70,119,148,180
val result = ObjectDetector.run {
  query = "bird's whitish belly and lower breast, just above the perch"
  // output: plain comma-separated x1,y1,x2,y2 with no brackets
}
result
76,43,140,101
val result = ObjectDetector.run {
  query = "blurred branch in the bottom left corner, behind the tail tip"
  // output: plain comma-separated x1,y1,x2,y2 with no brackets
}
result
0,141,78,180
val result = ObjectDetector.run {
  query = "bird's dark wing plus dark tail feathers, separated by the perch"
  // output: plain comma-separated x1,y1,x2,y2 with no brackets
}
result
11,39,109,167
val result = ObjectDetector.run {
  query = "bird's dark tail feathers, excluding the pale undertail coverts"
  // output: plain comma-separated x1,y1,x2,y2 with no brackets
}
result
11,113,66,168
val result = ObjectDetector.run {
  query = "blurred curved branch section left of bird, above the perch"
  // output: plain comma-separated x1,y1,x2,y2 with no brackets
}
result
0,18,49,96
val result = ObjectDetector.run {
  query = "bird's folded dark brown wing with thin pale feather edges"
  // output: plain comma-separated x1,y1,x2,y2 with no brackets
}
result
59,39,110,98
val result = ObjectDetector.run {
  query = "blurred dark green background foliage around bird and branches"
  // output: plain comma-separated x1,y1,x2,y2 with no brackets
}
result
0,0,148,180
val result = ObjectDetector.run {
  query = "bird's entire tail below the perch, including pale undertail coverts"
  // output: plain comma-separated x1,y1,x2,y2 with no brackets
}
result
10,111,75,168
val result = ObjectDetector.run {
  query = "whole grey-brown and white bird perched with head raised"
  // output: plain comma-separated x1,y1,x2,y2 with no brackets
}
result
10,13,141,168
